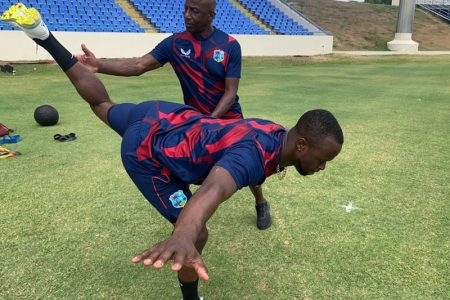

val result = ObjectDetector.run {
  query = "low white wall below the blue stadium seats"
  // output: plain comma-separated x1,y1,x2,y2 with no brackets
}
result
0,31,333,61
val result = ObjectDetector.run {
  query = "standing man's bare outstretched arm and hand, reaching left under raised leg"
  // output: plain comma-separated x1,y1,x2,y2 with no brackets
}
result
76,44,162,76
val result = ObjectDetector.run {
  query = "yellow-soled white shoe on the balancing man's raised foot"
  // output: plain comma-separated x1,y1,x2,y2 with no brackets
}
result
0,2,50,40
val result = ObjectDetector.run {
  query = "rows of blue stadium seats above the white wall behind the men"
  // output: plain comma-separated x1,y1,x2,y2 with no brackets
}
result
0,0,314,35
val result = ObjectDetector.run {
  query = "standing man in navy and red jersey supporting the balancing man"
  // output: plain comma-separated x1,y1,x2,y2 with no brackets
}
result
77,0,272,229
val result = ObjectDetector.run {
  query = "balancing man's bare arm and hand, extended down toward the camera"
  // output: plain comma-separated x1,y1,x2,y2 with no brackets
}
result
132,167,237,280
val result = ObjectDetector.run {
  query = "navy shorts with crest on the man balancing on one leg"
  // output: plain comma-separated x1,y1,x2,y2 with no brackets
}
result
108,102,192,223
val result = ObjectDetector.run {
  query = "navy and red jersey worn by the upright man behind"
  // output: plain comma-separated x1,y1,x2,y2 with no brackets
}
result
150,28,242,119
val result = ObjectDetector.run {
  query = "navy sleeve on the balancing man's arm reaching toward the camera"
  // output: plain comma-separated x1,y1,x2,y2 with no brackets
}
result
216,143,265,189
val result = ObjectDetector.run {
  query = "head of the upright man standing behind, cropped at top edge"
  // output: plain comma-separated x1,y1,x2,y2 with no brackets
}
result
184,0,215,34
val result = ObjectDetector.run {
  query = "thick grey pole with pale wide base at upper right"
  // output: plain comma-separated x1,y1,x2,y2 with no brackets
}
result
387,0,419,52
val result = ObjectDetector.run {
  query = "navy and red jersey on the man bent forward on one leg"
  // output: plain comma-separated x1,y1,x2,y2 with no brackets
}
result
136,101,287,189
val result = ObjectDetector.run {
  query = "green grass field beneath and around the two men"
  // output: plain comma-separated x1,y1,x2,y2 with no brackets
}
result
0,56,450,300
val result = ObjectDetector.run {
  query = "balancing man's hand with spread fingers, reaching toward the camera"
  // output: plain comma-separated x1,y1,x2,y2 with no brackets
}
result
131,234,209,281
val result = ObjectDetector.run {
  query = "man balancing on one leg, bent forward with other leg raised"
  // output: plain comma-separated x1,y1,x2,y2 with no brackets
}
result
0,4,344,299
